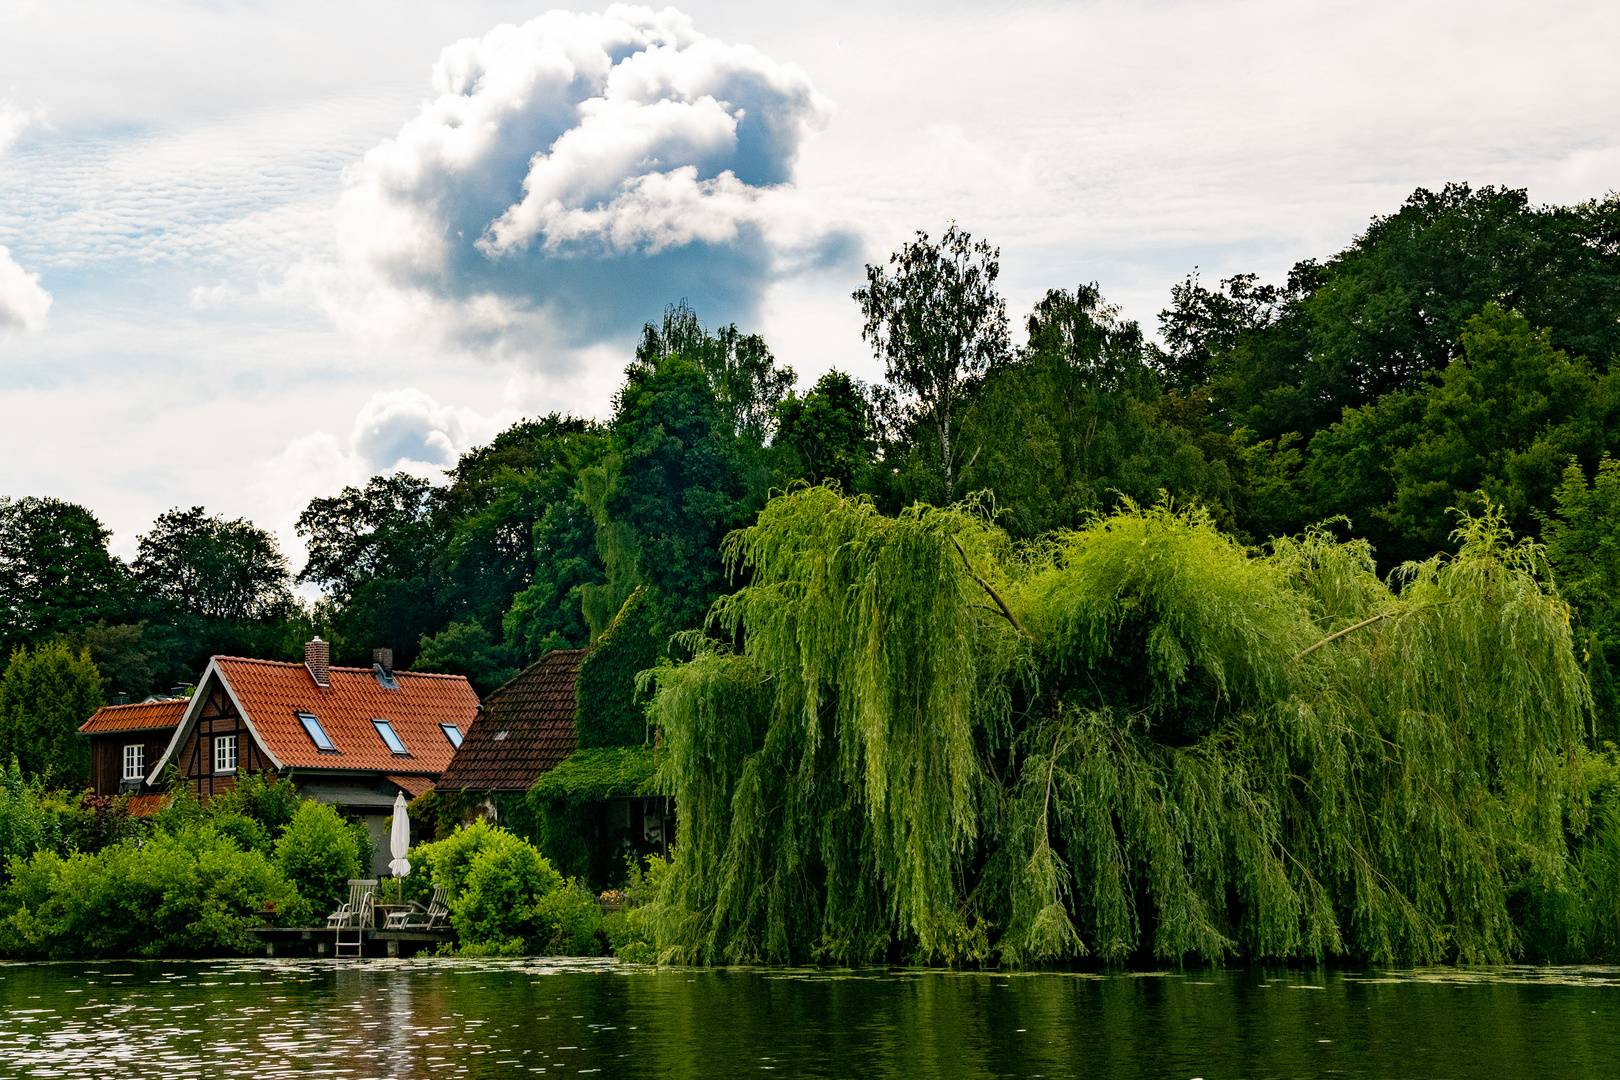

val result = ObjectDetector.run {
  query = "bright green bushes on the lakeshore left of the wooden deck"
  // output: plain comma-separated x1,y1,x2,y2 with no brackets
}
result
0,826,309,959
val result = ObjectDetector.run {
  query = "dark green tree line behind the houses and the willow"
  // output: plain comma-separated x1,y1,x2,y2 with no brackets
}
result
0,185,1620,777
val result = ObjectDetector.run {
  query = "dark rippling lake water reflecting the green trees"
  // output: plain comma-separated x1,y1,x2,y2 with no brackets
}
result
0,959,1620,1080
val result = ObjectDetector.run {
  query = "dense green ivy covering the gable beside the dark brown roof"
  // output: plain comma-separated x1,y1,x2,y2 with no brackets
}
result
573,586,661,750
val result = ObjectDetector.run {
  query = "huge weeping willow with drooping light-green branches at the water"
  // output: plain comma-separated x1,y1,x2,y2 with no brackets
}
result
651,489,1588,963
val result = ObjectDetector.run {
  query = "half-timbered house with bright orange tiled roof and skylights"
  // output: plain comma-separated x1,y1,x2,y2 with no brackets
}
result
140,638,478,873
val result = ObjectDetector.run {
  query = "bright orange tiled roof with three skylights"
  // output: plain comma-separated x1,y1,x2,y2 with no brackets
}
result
214,656,478,773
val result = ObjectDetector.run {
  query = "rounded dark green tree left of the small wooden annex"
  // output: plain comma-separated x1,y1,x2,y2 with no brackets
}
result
0,641,105,784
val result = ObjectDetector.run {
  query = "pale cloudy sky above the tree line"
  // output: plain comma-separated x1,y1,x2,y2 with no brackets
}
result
0,0,1620,567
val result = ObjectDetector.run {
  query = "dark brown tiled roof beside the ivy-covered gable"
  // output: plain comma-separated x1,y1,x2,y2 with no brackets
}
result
436,649,588,792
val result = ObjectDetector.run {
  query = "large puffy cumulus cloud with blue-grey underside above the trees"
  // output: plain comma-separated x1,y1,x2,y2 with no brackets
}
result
322,5,852,356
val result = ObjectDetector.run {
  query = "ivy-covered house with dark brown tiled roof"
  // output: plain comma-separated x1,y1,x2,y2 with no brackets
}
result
434,636,674,889
